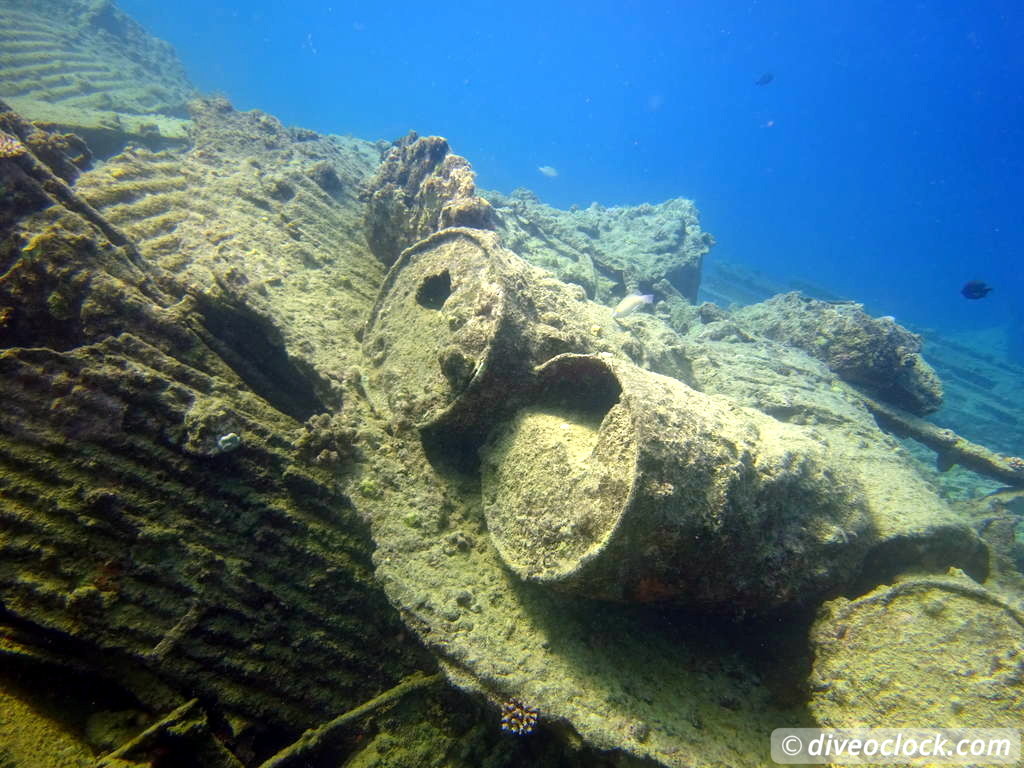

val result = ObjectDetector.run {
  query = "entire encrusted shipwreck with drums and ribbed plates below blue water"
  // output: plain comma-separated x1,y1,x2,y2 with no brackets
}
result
0,0,1024,768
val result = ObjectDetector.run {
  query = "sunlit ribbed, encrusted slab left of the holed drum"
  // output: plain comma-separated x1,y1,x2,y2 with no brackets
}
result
78,99,384,409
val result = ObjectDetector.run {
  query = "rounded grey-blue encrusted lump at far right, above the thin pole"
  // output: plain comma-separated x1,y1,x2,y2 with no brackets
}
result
734,293,942,416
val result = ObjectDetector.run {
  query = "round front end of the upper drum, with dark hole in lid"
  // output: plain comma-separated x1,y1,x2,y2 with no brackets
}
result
362,228,529,428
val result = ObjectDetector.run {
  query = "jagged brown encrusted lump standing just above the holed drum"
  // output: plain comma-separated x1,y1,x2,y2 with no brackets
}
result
364,131,495,266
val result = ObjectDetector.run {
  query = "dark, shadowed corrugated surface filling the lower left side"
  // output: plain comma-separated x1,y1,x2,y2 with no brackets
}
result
0,102,430,757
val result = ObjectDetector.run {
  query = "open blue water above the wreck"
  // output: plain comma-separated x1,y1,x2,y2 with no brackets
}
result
121,0,1024,339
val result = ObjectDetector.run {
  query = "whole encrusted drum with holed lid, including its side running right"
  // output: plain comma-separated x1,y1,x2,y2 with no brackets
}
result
362,227,686,440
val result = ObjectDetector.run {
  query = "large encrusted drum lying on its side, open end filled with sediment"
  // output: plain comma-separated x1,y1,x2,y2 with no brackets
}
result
482,354,871,611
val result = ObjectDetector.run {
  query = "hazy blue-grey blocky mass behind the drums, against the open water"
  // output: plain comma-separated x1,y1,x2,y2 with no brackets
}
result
487,189,715,306
